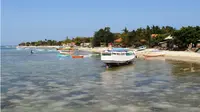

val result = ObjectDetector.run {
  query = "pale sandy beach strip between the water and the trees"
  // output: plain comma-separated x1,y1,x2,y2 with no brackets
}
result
16,46,200,64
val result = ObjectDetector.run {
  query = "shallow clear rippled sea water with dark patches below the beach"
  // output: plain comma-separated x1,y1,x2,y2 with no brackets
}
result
1,48,200,112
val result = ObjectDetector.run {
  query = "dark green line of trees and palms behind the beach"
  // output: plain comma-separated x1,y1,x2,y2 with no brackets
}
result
19,25,200,49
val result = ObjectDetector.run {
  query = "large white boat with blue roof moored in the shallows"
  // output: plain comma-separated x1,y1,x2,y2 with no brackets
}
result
101,48,136,66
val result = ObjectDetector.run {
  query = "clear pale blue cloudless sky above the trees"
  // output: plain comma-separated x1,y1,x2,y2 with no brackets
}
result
1,0,200,45
